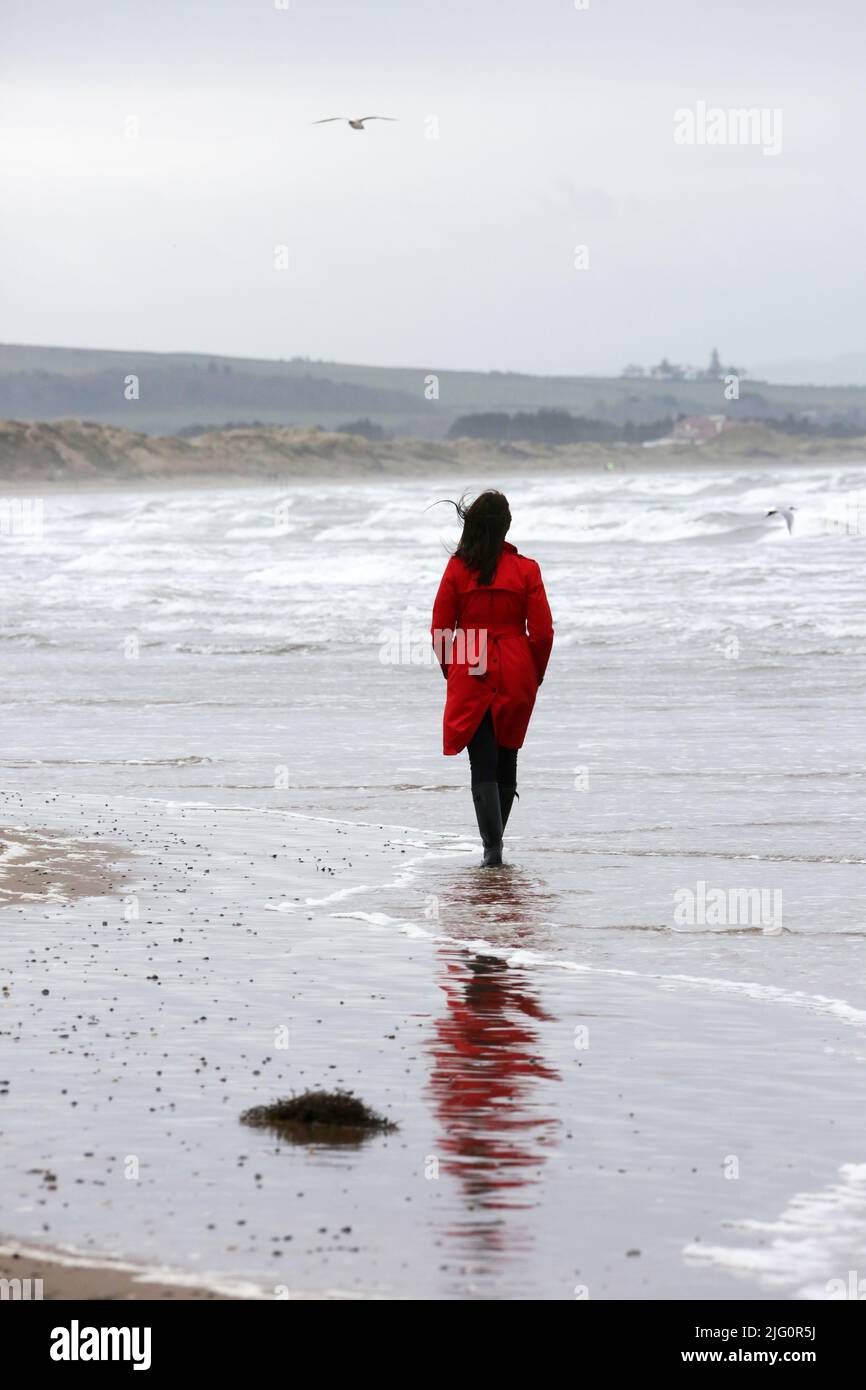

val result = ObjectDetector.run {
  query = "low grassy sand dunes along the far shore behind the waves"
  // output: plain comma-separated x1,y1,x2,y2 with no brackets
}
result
0,420,866,489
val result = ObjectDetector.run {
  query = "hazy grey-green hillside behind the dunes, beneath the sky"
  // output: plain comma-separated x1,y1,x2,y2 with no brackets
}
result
0,346,866,439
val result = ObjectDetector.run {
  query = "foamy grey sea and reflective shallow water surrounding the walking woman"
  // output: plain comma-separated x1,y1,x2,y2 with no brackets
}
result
0,463,866,1298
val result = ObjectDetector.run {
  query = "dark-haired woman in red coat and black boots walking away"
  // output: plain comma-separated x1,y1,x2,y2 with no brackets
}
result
431,491,553,867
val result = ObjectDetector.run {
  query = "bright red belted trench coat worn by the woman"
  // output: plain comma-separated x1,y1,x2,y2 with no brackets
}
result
431,541,553,755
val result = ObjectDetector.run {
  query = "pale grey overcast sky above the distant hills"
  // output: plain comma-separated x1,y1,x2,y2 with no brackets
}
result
0,0,866,373
